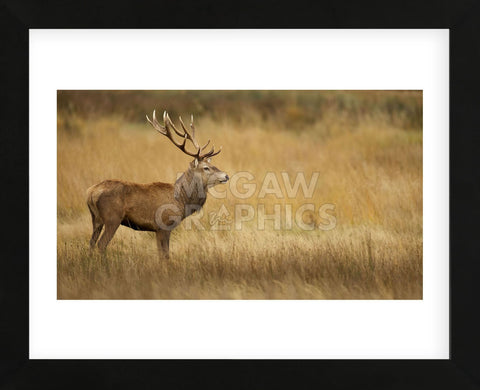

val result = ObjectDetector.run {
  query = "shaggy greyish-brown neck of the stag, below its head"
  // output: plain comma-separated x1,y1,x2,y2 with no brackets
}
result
174,169,207,217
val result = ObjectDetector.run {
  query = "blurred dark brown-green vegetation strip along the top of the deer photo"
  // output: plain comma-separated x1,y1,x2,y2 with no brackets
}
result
57,90,423,131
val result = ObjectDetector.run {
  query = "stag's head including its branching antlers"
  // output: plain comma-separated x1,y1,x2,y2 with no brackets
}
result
147,110,229,188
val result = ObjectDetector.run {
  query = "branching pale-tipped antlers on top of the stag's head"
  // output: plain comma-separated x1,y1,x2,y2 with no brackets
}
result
145,110,222,160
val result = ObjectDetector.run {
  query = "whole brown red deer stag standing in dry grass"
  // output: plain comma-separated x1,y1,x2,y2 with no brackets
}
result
87,111,229,259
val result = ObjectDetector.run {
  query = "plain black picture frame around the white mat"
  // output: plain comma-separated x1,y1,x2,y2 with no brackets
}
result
0,0,480,389
